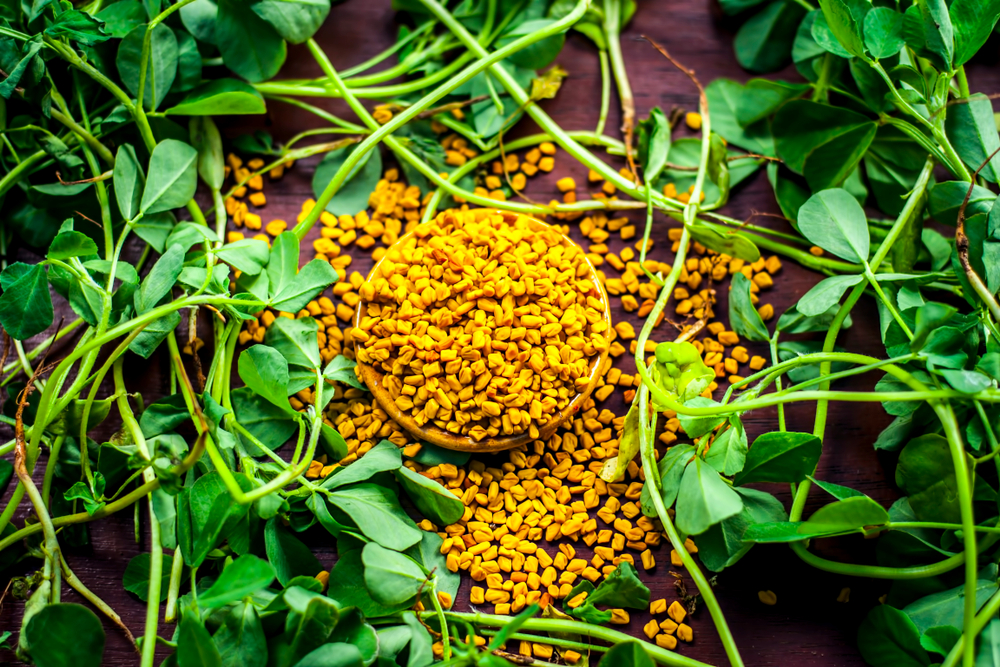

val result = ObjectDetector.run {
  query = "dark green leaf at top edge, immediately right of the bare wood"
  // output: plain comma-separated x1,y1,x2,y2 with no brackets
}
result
733,0,805,72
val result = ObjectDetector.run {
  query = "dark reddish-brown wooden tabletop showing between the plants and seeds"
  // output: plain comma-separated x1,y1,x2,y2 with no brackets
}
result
0,0,1000,667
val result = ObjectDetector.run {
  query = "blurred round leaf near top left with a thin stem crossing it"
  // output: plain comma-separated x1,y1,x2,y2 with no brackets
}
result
115,23,179,109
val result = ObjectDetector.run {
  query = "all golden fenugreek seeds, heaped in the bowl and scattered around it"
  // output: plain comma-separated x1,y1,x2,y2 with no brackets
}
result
226,130,781,661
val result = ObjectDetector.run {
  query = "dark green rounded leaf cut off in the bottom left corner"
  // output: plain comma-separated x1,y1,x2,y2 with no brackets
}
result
24,603,104,667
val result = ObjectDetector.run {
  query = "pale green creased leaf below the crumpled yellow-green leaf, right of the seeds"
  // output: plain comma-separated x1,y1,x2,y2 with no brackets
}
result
674,460,753,535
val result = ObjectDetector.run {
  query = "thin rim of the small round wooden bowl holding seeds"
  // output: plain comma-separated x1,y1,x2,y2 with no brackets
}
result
353,210,611,452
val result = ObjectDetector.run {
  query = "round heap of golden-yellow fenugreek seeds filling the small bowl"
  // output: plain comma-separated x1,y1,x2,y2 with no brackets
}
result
353,209,610,441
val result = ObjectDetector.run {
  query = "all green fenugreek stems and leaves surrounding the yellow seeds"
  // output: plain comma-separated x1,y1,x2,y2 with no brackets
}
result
0,0,1000,667
